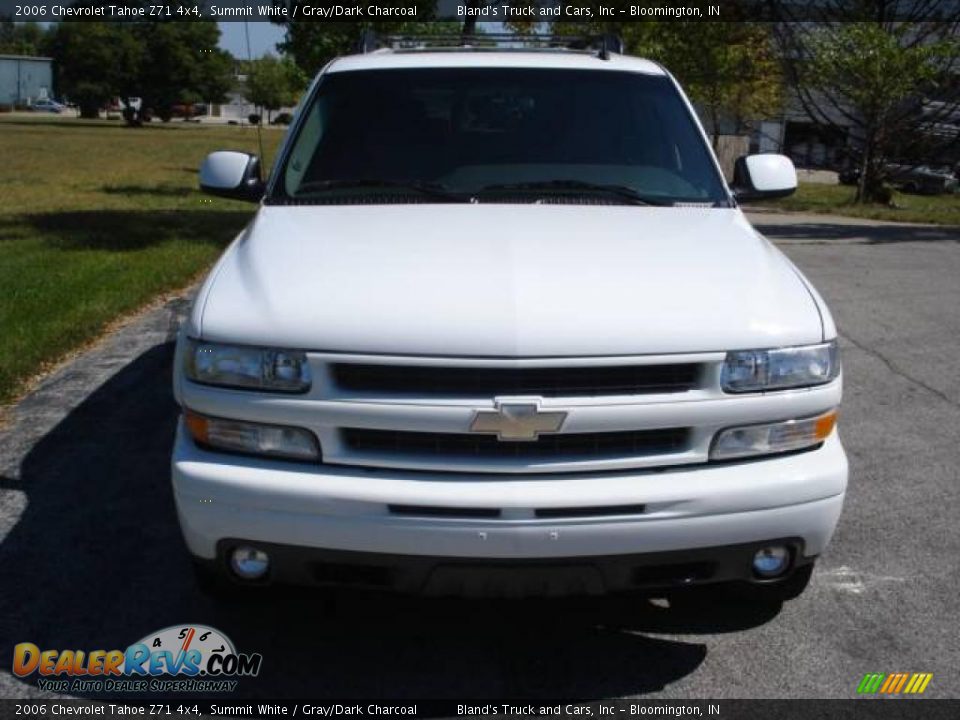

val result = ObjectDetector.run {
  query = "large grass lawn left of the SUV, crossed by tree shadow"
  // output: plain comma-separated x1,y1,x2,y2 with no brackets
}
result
0,116,282,405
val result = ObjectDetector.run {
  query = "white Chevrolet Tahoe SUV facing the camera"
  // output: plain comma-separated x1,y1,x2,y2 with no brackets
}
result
172,41,847,598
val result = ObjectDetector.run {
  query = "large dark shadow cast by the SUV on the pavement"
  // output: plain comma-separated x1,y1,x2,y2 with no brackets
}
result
0,344,778,698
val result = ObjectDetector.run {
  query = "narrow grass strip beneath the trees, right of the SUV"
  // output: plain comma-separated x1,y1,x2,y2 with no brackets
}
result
758,183,960,225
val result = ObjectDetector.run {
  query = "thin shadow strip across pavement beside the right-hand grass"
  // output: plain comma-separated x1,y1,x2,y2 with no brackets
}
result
754,217,960,245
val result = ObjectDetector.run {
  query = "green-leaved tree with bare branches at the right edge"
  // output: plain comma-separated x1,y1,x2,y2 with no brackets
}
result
778,6,960,202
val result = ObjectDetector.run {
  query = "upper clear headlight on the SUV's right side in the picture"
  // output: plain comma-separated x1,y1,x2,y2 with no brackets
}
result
720,340,840,393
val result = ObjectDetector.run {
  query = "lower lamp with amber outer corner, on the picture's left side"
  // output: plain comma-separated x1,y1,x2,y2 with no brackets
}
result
183,410,320,461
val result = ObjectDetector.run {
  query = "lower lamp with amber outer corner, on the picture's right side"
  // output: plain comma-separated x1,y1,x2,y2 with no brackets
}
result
710,410,837,460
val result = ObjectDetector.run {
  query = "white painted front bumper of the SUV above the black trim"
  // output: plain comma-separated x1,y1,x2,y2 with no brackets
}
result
172,426,847,592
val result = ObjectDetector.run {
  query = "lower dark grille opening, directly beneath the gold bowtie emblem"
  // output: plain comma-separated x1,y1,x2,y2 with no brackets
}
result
340,428,690,460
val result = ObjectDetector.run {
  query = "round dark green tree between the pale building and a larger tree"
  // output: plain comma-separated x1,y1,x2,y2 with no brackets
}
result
50,22,144,118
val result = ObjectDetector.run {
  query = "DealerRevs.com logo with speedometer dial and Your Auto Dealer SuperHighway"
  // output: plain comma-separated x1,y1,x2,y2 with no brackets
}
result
13,625,263,692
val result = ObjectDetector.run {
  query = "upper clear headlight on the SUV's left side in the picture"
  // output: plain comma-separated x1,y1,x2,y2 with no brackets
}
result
184,340,310,393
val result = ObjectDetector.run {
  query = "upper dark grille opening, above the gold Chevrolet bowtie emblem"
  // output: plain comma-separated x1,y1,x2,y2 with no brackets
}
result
331,363,703,397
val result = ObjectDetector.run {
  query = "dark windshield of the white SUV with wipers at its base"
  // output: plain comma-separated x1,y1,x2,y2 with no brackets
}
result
274,68,727,206
